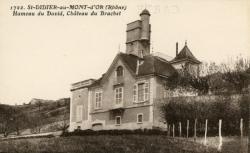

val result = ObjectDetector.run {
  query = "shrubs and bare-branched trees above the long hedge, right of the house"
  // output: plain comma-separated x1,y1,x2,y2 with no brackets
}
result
166,57,250,94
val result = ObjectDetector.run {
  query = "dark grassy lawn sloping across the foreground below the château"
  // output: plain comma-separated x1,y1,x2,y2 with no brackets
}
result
0,135,217,153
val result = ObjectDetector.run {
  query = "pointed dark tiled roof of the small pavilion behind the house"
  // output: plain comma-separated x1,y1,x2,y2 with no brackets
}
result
171,45,201,63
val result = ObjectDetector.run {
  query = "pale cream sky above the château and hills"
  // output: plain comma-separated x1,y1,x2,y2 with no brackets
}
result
0,0,250,105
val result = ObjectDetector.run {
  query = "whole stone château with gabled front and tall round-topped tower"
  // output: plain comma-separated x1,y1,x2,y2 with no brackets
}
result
70,9,200,131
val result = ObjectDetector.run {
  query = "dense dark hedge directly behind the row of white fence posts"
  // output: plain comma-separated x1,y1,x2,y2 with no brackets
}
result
161,95,249,135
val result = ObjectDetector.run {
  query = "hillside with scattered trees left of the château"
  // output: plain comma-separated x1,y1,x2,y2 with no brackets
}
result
0,98,70,134
